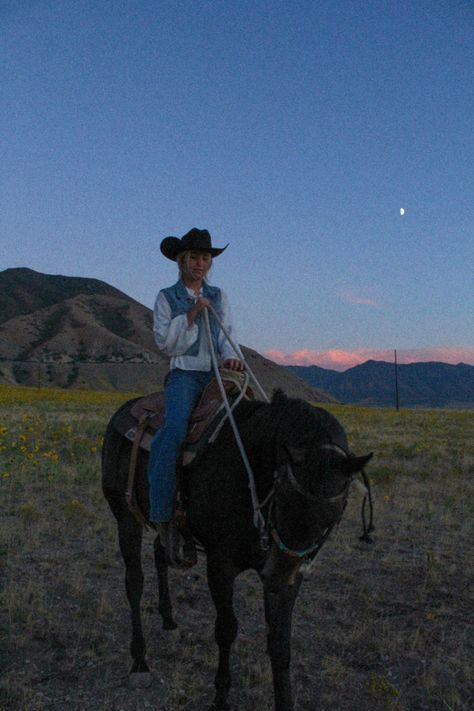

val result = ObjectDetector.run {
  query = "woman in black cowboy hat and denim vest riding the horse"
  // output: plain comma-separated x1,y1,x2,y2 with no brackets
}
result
148,228,244,567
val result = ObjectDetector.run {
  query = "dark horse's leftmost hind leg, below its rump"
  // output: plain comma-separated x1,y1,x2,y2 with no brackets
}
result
118,511,149,674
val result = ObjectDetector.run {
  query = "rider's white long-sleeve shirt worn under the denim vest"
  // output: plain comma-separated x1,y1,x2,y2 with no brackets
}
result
153,287,242,371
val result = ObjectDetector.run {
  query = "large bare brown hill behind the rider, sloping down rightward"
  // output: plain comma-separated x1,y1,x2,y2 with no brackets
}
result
0,268,334,402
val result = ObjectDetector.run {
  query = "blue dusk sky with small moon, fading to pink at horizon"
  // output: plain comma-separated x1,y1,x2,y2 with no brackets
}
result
0,0,474,370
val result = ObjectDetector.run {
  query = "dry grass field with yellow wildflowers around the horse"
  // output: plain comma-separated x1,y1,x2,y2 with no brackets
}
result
0,387,474,711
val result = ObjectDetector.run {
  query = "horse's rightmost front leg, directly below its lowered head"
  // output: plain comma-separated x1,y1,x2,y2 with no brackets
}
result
264,575,302,711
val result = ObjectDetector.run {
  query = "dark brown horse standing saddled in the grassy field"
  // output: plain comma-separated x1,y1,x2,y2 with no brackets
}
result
102,392,371,711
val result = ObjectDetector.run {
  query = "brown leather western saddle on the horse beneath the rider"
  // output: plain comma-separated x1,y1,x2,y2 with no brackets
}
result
115,369,255,466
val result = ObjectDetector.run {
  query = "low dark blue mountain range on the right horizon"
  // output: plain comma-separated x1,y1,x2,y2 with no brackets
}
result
287,360,474,408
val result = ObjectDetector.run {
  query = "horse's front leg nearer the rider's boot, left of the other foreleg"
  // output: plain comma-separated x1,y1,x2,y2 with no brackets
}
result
207,556,238,711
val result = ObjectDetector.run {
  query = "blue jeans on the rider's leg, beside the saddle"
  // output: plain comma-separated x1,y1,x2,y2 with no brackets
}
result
148,368,213,523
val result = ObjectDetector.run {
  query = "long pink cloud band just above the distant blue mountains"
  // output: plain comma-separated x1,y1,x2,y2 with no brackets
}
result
265,346,474,371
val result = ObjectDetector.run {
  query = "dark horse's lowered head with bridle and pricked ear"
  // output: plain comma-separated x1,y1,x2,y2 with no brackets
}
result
262,392,372,588
